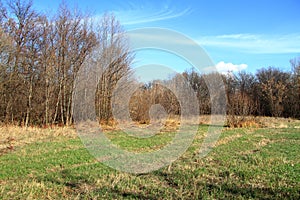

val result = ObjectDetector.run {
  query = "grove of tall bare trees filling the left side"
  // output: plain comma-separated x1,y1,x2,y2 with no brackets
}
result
0,0,131,126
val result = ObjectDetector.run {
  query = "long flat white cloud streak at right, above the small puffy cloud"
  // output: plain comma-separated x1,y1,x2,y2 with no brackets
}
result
197,34,300,54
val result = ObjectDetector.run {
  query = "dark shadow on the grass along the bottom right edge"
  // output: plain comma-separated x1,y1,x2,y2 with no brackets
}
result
154,171,300,199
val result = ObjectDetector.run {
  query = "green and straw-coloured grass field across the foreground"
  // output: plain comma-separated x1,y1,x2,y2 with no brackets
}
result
0,119,300,199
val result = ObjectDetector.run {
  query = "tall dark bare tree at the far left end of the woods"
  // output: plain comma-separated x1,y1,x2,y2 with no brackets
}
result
1,0,38,126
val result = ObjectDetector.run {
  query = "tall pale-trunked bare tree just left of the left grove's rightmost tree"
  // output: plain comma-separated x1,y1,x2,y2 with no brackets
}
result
53,4,97,125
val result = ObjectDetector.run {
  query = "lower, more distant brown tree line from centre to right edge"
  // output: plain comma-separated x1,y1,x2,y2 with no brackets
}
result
127,62,300,126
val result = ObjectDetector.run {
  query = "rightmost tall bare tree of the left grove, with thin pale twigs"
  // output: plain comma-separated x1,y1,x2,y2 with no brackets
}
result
96,14,133,123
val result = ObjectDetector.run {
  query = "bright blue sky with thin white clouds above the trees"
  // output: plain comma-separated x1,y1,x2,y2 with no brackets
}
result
34,0,300,72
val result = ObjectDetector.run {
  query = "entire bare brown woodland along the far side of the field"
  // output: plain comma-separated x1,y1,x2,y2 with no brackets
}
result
0,0,300,127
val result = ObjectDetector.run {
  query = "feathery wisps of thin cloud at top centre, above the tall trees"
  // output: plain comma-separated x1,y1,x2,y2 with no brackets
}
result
113,1,192,25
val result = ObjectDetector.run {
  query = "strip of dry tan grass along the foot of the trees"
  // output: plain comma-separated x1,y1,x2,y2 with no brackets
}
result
0,115,300,155
